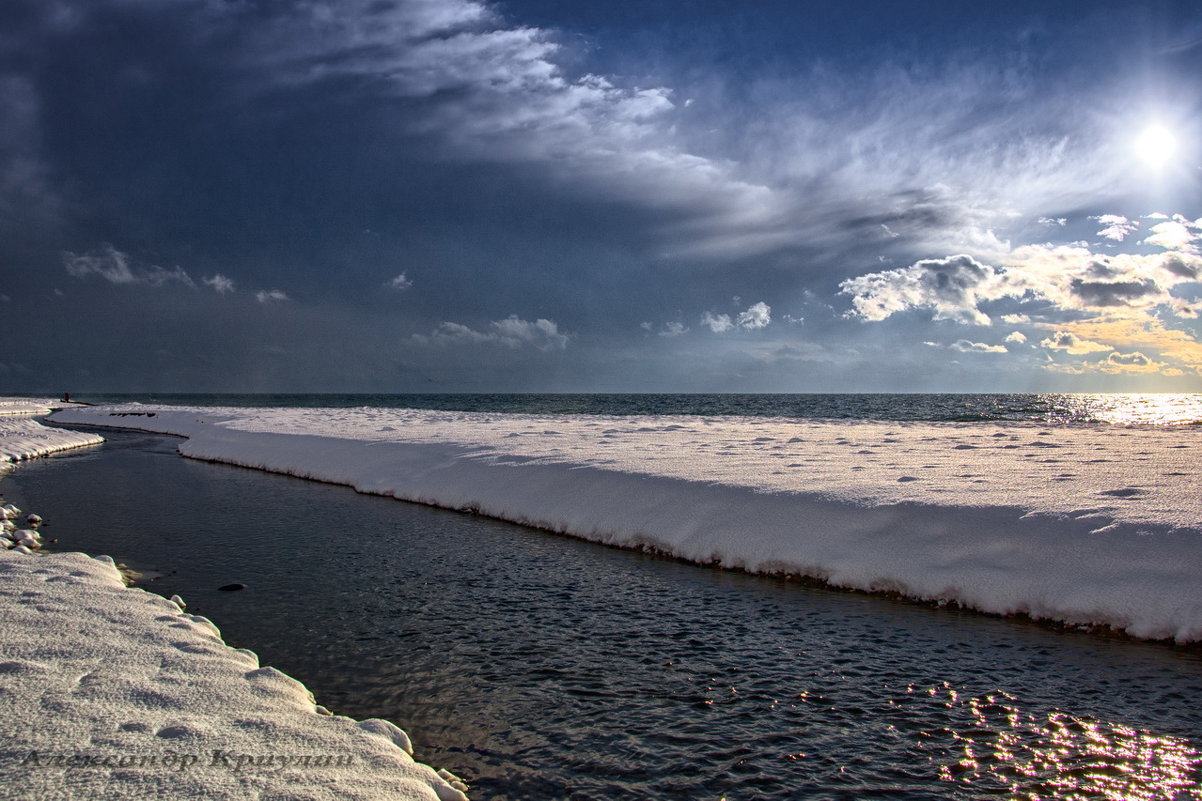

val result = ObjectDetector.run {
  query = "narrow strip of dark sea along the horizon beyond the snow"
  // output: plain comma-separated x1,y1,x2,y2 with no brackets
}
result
32,393,1202,425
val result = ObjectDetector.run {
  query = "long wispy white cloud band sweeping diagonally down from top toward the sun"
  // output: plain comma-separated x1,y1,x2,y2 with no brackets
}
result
167,0,1134,257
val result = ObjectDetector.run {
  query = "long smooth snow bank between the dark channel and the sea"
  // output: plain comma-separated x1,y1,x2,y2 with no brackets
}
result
55,404,1202,642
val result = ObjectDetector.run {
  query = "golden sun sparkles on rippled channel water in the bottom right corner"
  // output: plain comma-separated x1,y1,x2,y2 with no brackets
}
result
910,683,1202,801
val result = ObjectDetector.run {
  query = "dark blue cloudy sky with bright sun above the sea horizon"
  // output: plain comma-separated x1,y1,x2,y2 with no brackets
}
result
0,0,1202,396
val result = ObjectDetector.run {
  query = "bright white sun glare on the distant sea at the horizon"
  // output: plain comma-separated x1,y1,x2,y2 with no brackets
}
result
1039,392,1202,426
